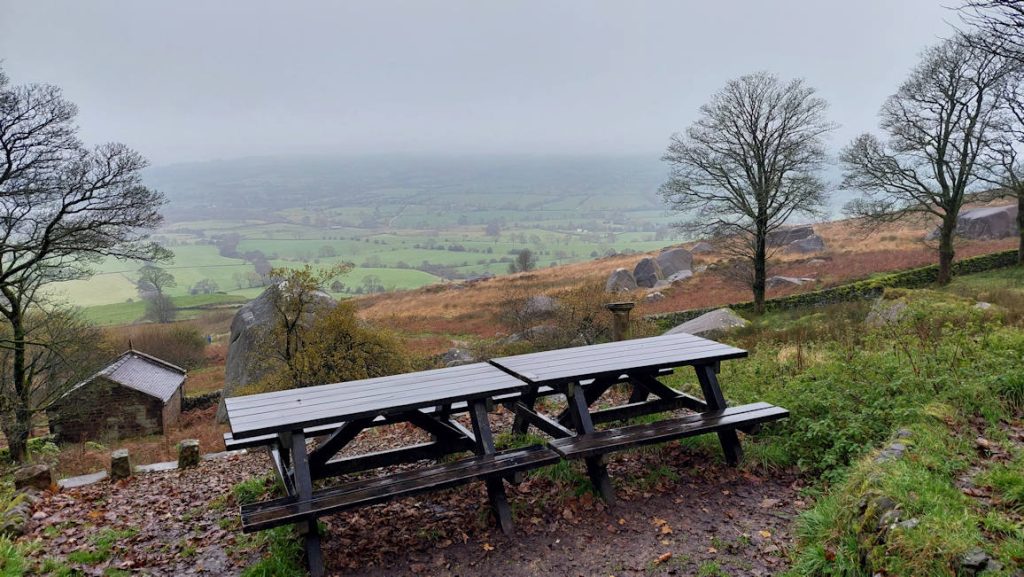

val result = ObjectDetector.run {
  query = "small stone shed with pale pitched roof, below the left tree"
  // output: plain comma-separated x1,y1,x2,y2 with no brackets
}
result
46,351,185,443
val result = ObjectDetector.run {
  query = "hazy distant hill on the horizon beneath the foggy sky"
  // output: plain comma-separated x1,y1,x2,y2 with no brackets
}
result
145,156,667,221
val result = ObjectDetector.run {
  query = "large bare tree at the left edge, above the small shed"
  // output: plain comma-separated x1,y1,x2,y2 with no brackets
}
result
0,67,169,461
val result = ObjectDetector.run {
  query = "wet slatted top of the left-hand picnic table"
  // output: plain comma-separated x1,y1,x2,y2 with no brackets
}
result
224,363,528,439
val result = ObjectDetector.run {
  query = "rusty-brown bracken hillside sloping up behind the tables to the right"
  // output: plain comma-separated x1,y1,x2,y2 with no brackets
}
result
358,214,1017,352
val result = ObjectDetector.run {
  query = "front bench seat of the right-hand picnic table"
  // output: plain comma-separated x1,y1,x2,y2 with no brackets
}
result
548,403,790,458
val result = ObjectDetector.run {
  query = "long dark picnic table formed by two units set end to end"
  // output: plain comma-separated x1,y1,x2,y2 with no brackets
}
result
225,334,787,576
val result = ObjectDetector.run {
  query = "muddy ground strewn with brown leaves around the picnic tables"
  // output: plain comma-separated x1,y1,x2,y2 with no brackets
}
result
26,445,802,577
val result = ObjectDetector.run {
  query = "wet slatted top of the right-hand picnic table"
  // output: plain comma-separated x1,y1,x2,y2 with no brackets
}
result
490,333,746,384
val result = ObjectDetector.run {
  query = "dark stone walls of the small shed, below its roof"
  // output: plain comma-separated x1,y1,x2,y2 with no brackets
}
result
47,377,169,443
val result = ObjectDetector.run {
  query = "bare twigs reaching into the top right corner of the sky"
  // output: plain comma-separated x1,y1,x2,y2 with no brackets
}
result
959,0,1024,63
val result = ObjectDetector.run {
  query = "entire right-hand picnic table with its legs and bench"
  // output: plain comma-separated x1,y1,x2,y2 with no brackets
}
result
492,333,788,504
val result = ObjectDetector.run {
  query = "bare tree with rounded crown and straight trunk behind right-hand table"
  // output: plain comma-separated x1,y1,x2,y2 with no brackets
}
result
660,72,835,312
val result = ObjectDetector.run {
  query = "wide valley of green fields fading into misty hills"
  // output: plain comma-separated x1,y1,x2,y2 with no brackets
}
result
49,157,696,315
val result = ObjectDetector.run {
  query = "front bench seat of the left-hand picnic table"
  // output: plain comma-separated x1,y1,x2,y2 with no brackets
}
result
242,445,560,533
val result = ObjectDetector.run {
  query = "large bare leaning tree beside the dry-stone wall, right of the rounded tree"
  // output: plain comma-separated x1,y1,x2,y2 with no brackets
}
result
841,36,1008,284
